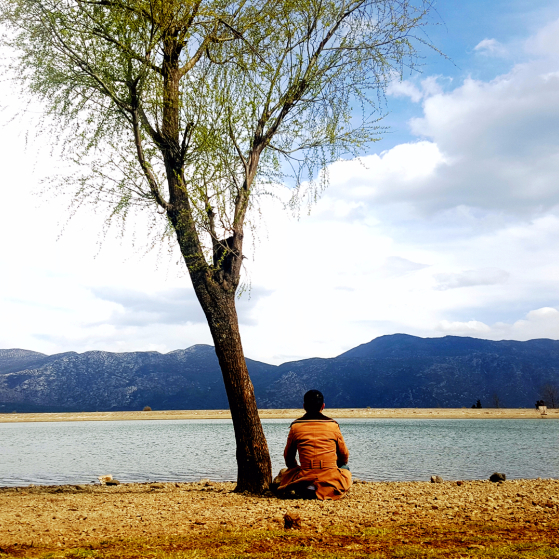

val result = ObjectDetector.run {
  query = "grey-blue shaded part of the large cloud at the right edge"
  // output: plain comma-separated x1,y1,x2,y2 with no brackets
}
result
412,65,559,213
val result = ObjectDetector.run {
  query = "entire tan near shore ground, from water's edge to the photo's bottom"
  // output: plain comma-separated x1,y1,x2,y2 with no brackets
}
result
0,479,559,559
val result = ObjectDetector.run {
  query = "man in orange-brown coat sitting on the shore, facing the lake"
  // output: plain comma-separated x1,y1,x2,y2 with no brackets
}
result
278,390,351,500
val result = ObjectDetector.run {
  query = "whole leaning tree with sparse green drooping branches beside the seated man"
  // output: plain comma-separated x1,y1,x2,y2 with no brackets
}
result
0,0,436,492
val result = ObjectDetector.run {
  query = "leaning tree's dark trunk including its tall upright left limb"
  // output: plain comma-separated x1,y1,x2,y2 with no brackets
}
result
161,29,272,494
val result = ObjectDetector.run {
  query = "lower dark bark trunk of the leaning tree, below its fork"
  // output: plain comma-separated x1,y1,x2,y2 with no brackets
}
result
192,274,272,494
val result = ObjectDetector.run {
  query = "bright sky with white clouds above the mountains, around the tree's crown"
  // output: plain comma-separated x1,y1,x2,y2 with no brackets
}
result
0,0,559,364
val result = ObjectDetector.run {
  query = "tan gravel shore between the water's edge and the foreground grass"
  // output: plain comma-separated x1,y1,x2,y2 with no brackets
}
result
0,479,559,555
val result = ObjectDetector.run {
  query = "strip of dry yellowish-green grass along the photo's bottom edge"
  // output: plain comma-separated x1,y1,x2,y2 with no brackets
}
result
0,523,559,559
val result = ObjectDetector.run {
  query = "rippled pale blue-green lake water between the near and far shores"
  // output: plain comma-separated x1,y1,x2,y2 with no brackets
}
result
0,419,559,486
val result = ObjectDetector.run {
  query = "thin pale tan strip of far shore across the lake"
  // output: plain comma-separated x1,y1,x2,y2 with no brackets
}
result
0,408,559,423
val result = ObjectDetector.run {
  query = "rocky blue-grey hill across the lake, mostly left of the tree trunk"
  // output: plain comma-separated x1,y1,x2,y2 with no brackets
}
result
0,345,277,412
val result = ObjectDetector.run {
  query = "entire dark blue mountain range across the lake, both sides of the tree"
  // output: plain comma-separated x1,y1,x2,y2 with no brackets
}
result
0,334,559,413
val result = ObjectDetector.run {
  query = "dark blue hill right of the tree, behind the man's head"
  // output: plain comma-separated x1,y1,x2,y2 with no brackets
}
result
260,334,559,407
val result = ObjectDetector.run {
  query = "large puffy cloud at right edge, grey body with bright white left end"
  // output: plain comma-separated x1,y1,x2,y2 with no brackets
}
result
326,38,559,219
